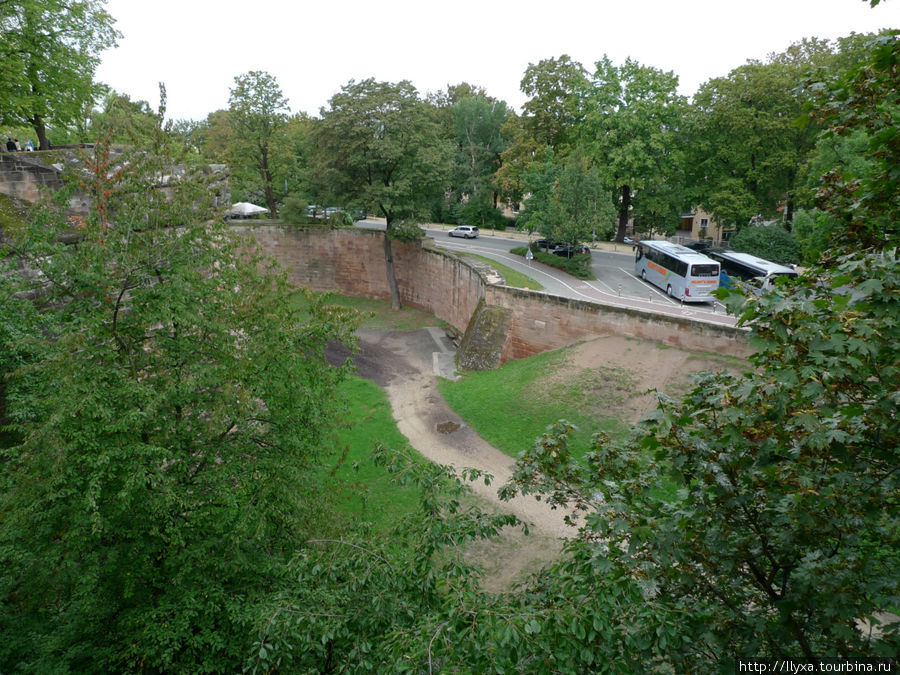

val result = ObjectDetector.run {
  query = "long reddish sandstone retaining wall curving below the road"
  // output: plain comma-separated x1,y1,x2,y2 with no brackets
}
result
235,225,750,367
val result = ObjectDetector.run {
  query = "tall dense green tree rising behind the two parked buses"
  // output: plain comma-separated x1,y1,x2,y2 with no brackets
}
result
685,38,860,227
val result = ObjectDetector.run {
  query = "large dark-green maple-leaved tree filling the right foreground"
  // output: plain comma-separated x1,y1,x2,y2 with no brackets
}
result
506,29,900,672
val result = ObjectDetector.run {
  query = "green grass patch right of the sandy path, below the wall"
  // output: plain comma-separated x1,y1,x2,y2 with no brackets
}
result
438,349,630,457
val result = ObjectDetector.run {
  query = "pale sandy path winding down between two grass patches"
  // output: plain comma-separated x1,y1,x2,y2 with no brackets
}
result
355,329,574,537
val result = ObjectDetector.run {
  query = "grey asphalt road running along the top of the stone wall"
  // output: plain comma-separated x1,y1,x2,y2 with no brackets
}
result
358,221,736,326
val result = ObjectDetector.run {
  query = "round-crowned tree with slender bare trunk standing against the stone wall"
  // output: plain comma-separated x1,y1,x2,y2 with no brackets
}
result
314,79,453,309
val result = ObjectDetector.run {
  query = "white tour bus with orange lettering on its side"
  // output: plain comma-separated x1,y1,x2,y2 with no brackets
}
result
634,241,719,302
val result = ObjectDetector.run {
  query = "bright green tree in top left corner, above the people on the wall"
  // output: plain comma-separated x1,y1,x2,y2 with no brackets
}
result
0,0,121,150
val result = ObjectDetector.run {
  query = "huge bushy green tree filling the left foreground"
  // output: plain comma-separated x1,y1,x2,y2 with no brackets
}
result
0,119,355,672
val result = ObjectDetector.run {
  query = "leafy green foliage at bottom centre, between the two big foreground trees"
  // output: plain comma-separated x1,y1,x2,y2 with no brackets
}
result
247,447,517,672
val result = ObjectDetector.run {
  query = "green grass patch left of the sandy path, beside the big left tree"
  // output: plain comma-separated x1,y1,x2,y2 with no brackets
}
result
321,377,426,532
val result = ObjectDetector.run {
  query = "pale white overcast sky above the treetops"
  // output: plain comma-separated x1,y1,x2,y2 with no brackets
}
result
97,0,900,120
